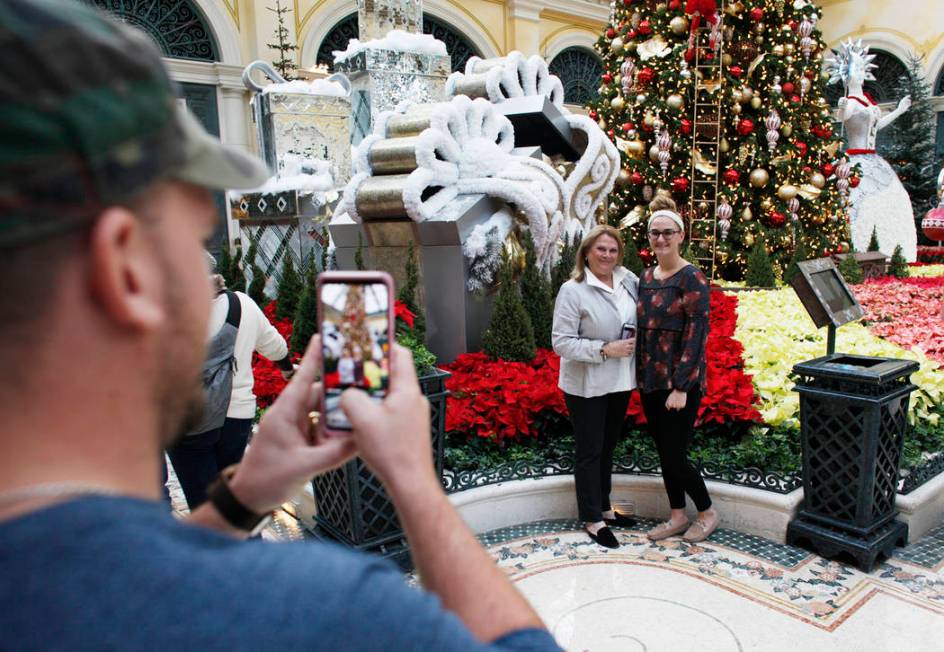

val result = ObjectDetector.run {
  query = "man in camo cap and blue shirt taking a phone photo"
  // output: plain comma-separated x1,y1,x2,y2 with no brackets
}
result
0,0,557,650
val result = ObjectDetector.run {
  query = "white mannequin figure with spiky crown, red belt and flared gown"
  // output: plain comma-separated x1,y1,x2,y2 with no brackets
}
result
828,39,918,262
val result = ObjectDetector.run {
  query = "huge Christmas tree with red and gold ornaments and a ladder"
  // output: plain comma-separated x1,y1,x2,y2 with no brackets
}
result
588,0,857,280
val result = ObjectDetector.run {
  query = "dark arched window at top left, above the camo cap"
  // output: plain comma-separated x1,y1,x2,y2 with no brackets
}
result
85,0,220,61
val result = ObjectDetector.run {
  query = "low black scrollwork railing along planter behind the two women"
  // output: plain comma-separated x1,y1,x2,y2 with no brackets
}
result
442,452,803,494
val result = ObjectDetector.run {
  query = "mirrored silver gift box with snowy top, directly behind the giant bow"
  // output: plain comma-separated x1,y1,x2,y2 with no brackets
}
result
335,48,452,145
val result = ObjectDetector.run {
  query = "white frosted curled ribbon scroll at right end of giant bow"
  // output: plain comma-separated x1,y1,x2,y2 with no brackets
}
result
564,114,620,231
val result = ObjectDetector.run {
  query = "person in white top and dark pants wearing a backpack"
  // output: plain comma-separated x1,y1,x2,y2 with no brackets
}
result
167,260,293,509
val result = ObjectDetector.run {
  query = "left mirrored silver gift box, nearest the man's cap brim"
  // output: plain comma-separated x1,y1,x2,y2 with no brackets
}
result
255,91,351,188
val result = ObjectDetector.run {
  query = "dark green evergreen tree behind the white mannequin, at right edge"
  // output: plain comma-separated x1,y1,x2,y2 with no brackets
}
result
879,53,937,224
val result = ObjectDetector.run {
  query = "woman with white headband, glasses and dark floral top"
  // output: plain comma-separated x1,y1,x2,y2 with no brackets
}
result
636,196,718,543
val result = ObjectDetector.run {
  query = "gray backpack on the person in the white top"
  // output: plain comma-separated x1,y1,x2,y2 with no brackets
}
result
187,292,242,435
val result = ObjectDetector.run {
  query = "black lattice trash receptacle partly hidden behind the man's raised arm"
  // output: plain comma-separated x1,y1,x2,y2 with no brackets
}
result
312,369,450,564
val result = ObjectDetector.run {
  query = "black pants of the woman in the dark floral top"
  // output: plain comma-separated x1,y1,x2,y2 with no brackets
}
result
642,389,711,512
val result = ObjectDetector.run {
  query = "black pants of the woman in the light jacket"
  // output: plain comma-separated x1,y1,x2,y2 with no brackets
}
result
564,392,630,523
